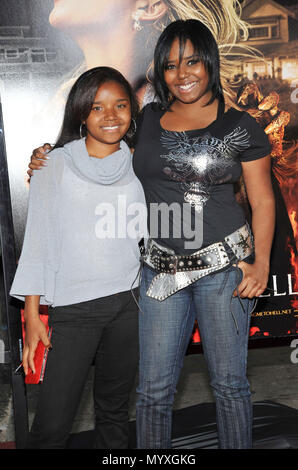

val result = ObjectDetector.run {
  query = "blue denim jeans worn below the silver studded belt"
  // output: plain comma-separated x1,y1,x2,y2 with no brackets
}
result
136,266,253,449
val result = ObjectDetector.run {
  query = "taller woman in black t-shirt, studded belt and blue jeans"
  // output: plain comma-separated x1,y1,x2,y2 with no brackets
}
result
133,20,275,449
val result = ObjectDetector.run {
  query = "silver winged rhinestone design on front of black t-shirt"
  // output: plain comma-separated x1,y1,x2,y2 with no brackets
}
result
161,127,249,212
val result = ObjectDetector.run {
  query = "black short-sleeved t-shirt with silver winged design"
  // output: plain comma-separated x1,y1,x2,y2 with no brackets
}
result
133,103,270,254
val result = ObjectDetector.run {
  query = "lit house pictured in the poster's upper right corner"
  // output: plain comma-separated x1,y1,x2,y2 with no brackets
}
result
237,0,298,82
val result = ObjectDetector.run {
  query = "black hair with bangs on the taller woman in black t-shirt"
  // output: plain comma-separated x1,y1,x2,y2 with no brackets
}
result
153,20,224,109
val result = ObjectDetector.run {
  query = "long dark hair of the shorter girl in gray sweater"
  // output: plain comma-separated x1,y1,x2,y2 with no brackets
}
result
54,67,139,148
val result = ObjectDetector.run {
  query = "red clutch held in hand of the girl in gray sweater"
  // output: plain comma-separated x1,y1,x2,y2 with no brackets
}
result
21,310,52,384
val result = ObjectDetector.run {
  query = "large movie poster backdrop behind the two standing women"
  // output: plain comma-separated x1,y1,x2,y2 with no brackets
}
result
0,0,298,343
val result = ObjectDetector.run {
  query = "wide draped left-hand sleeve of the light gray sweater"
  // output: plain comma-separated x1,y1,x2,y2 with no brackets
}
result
10,151,63,305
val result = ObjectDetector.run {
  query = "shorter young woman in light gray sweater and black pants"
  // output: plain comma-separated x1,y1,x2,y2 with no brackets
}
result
10,67,146,449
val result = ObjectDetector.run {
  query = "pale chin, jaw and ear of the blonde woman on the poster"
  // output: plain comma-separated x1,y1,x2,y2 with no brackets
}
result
49,0,168,85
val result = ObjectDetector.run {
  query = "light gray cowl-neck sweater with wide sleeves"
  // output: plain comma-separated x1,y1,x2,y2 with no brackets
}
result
10,139,146,306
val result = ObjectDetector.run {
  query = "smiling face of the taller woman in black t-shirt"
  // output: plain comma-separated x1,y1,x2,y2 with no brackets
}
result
164,38,209,104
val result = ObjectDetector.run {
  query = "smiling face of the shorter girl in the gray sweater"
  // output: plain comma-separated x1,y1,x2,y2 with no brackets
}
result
83,82,131,157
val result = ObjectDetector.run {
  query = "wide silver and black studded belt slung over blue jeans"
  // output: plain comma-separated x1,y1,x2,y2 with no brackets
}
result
142,223,254,300
